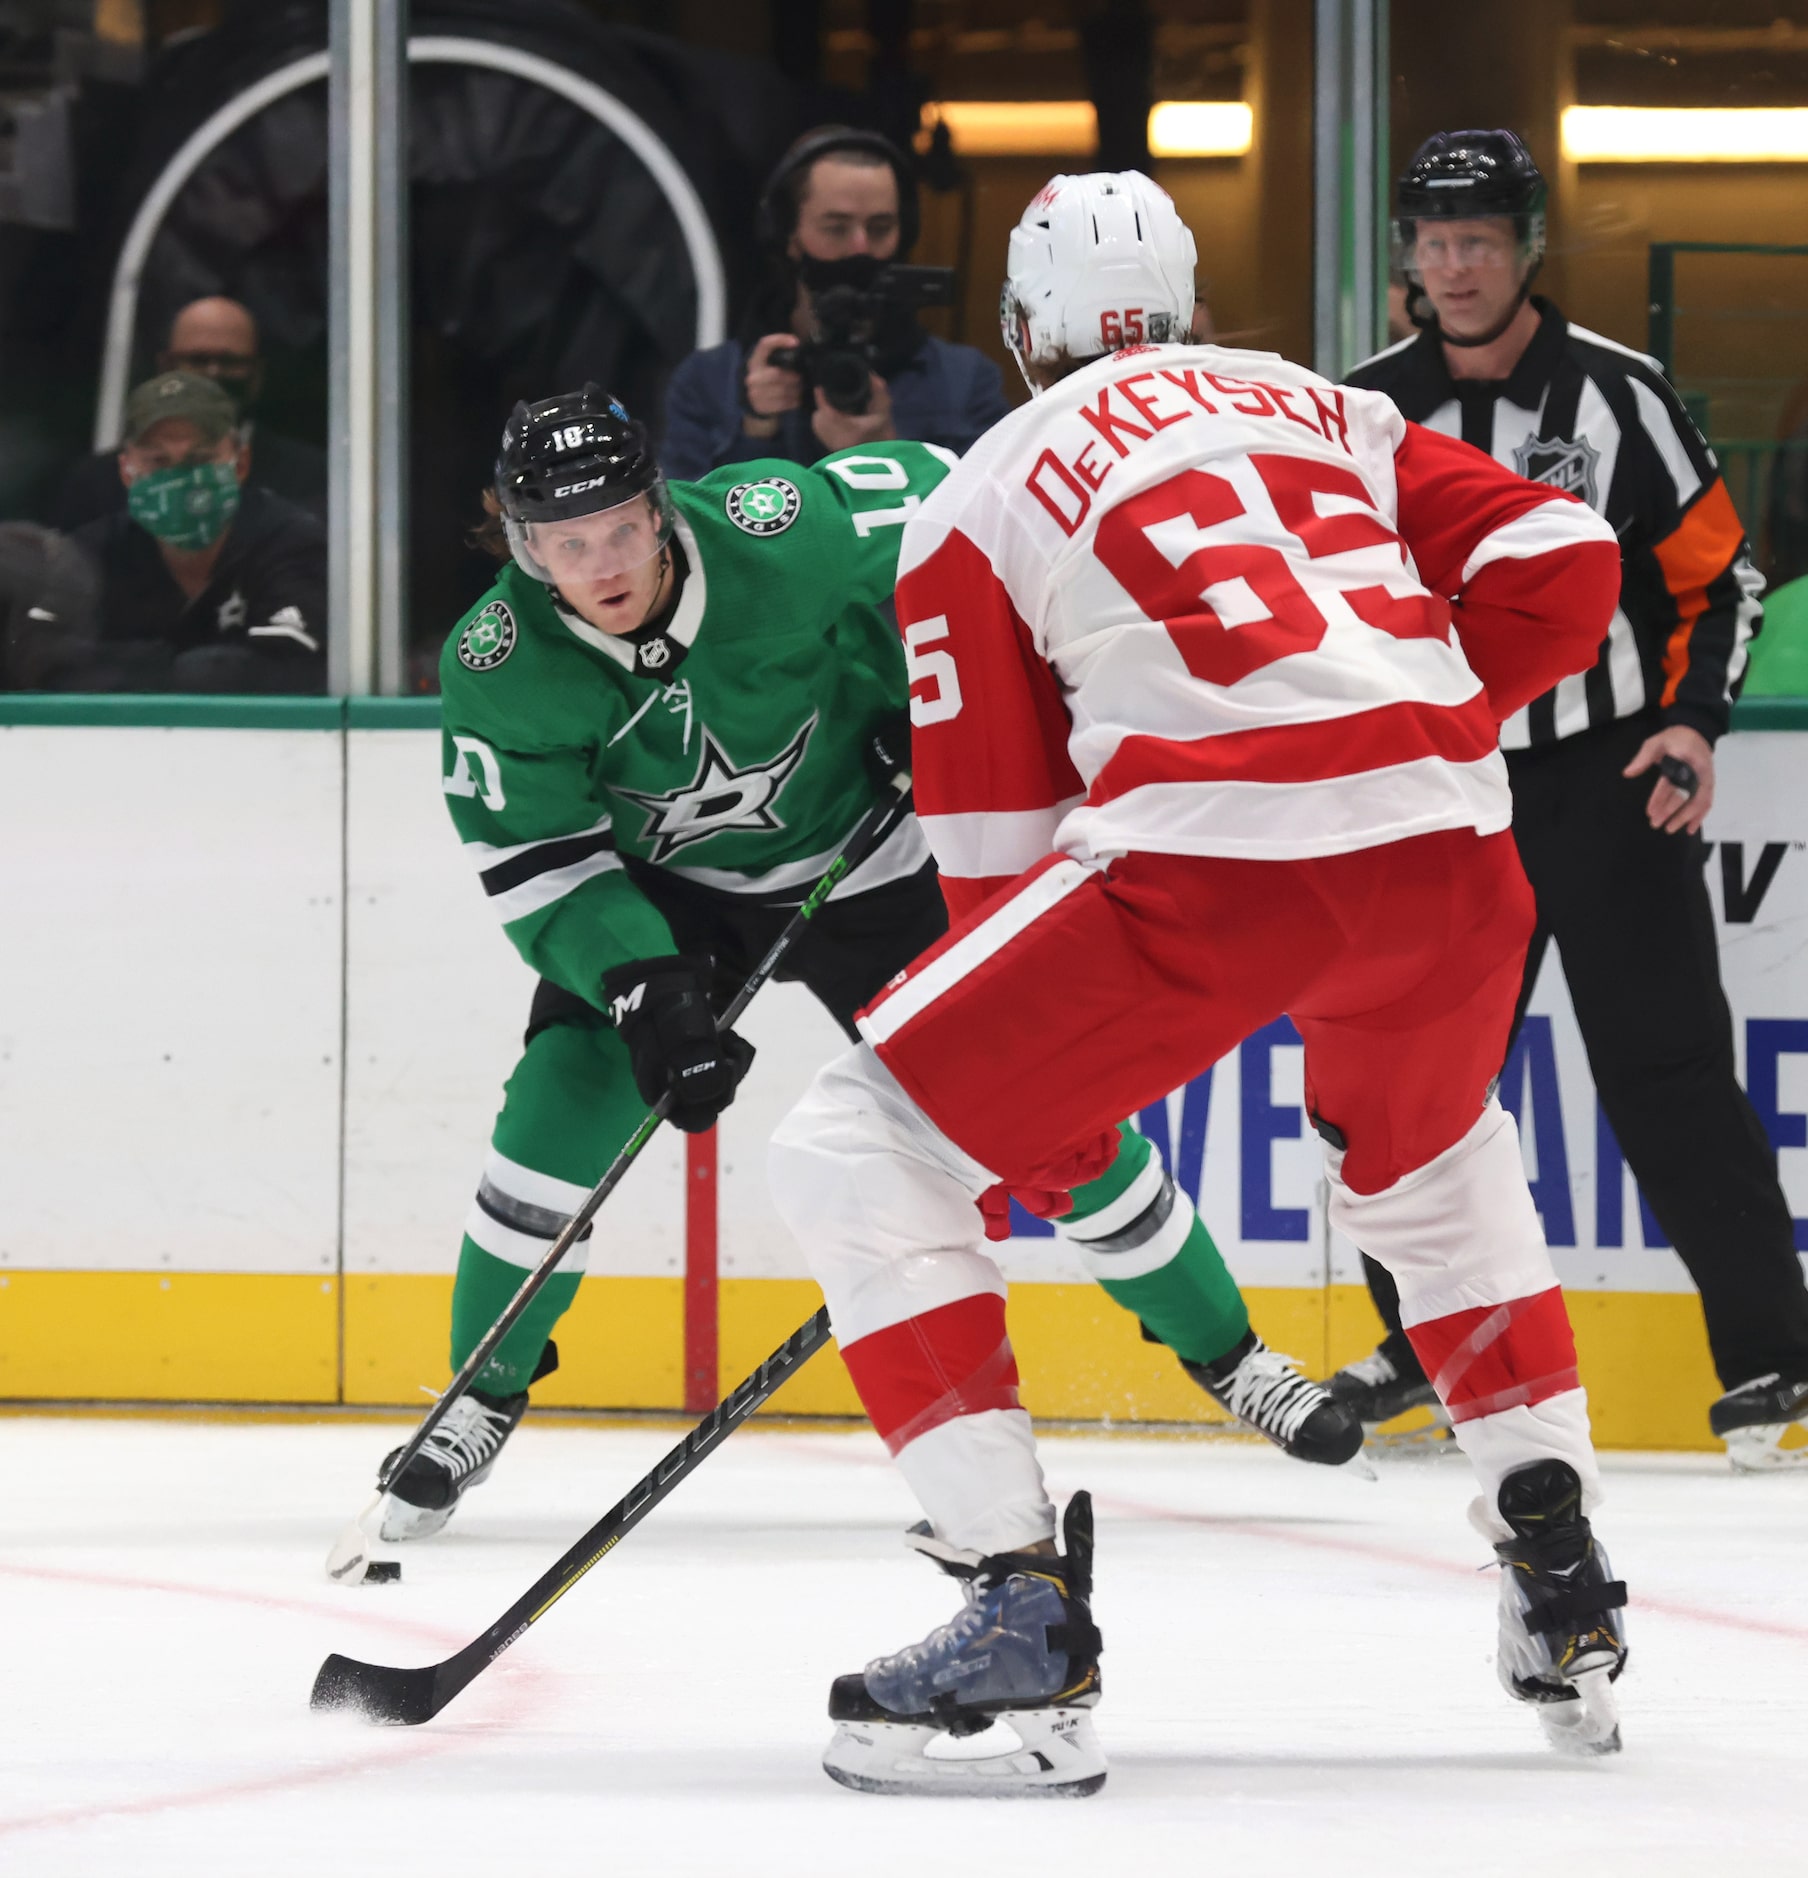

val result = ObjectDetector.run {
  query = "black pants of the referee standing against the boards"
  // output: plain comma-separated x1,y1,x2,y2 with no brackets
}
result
1363,714,1808,1388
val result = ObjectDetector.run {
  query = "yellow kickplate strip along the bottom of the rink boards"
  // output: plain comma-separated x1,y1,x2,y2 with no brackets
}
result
0,1270,1734,1452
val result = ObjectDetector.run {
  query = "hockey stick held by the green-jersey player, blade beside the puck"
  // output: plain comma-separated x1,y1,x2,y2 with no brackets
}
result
327,770,911,1585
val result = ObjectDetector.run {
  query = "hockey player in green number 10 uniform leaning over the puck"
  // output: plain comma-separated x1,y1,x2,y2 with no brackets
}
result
381,385,1361,1540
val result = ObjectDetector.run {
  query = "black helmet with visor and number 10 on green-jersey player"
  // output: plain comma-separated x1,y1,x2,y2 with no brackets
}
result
496,383,674,584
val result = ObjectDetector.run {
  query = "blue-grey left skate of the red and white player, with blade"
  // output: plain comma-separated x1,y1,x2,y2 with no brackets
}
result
822,1493,1106,1799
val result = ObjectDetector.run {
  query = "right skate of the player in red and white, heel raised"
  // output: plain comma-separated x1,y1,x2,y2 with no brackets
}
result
1494,1461,1626,1754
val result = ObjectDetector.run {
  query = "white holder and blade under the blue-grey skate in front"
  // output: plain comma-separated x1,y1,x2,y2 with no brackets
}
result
822,1709,1106,1799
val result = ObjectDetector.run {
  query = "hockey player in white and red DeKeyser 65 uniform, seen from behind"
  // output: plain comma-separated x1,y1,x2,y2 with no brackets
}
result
772,173,1626,1793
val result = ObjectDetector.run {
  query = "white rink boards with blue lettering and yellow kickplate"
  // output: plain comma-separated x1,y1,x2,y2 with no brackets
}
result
0,699,1808,1446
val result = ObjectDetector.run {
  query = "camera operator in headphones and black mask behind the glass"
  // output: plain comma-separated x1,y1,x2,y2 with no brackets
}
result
661,124,1008,481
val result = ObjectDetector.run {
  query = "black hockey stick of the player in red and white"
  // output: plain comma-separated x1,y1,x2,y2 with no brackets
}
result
308,1307,828,1726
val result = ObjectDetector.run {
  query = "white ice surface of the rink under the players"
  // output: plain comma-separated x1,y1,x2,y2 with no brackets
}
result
0,1418,1808,1878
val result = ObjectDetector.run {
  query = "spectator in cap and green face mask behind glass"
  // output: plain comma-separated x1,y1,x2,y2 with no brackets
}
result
54,372,327,691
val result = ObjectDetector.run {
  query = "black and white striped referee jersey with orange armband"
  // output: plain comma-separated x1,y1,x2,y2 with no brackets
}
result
1350,297,1765,749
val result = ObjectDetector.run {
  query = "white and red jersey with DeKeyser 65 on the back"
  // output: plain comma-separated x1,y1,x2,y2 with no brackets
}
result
897,346,1618,913
